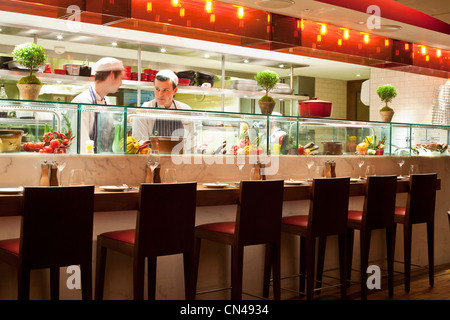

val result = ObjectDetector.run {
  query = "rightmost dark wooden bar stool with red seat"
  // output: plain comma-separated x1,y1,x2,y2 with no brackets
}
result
394,173,437,292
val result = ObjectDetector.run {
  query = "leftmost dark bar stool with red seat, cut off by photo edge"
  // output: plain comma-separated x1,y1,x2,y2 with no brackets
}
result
0,186,94,300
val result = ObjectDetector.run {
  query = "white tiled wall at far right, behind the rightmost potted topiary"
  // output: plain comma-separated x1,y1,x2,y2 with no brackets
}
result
370,68,447,124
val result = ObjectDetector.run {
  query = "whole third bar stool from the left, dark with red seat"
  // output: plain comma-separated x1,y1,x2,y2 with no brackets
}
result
195,180,284,300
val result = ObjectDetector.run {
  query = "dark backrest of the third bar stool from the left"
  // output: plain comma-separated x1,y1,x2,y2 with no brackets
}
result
235,180,284,245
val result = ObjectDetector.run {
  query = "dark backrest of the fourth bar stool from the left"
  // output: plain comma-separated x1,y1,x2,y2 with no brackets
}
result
308,177,350,236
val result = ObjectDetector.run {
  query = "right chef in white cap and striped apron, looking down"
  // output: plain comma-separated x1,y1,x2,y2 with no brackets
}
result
132,69,193,148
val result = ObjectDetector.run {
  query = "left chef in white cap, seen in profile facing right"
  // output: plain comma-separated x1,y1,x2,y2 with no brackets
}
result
72,57,124,153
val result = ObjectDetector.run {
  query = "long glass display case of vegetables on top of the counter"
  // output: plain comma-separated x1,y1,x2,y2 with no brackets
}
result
0,100,450,156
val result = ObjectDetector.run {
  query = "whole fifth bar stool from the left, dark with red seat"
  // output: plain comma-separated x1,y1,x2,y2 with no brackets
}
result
347,175,397,300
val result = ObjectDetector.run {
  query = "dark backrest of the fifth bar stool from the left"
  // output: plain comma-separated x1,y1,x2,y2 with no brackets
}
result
362,175,397,229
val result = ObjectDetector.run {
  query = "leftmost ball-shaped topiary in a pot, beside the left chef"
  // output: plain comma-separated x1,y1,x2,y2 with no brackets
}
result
12,43,47,100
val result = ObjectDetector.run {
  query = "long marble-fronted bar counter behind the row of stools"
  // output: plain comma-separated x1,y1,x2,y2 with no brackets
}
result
0,153,450,300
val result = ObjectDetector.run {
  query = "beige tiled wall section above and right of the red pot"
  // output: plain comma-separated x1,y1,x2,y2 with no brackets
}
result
315,78,347,119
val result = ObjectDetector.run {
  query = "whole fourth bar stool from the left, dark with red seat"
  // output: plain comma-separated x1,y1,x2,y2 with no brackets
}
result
270,177,350,299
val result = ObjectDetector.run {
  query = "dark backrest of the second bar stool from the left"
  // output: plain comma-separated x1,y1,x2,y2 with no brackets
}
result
135,182,197,256
